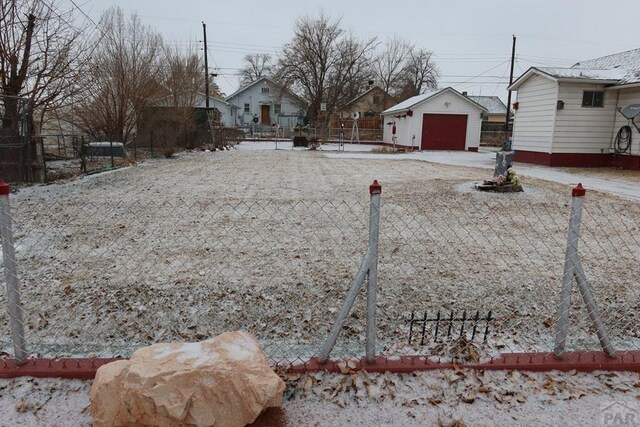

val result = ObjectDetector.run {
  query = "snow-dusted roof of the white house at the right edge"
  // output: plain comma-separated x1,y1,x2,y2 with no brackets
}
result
509,49,640,90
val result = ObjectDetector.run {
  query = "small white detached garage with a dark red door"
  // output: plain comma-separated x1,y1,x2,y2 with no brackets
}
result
382,87,487,151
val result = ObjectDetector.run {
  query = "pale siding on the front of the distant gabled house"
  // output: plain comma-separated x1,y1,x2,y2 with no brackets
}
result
227,81,303,128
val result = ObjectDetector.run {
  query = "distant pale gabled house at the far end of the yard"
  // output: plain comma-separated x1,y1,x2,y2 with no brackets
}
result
226,77,306,128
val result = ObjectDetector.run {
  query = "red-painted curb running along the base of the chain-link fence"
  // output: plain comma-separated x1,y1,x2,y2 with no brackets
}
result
0,350,640,380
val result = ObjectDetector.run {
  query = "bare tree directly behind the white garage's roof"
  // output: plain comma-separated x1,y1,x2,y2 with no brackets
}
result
398,49,438,100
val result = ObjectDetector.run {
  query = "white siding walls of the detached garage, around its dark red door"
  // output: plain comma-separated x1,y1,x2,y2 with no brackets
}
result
383,92,482,150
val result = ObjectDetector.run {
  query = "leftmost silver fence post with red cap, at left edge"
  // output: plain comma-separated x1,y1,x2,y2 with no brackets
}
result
0,179,27,363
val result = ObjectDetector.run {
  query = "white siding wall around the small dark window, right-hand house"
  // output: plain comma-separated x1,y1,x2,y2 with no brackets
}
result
552,82,617,154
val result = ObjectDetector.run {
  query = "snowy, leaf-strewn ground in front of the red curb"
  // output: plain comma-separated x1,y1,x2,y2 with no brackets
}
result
0,370,640,427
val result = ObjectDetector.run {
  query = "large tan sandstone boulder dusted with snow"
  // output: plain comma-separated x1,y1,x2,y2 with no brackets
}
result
91,332,285,427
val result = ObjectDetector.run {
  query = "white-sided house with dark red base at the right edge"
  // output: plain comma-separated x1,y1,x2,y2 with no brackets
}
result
509,49,640,169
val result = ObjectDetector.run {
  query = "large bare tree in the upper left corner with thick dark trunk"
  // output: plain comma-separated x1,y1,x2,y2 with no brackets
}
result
0,0,84,132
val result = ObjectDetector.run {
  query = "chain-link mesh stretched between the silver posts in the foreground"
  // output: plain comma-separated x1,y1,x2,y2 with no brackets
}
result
0,181,640,363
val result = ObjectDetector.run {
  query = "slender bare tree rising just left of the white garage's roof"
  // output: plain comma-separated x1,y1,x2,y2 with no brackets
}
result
372,36,414,108
